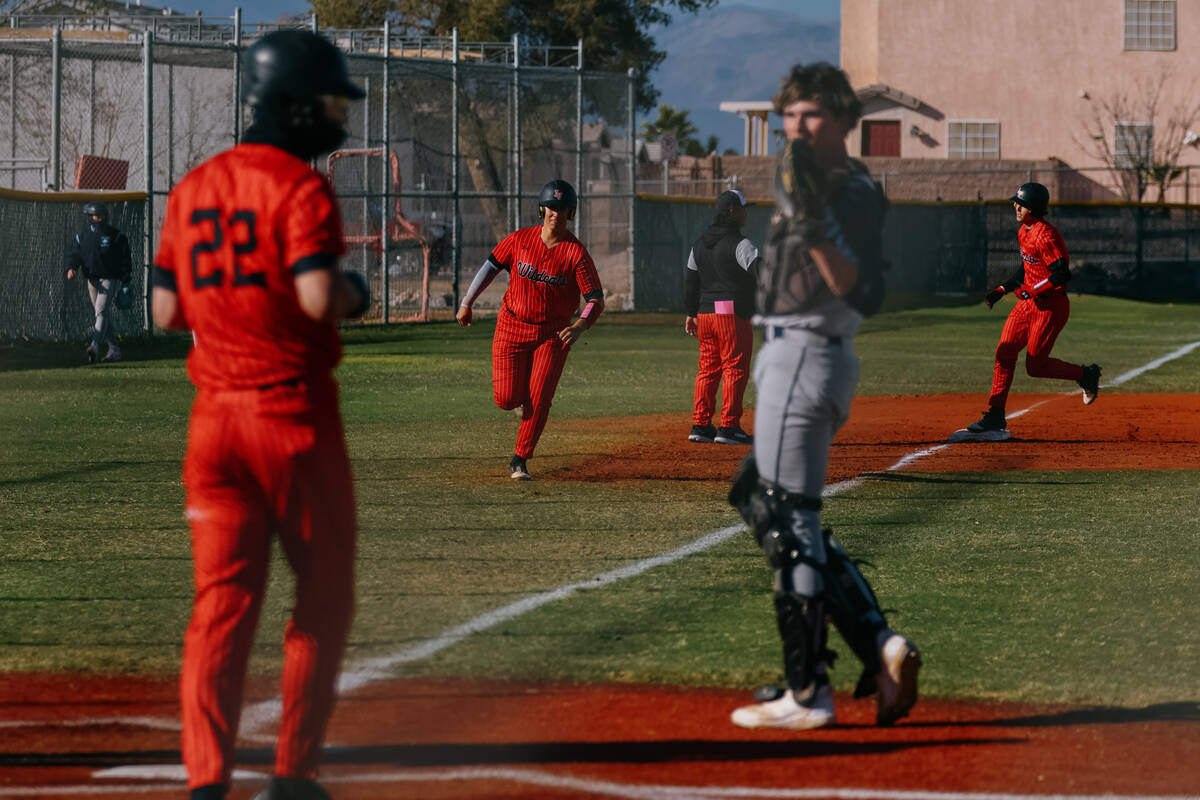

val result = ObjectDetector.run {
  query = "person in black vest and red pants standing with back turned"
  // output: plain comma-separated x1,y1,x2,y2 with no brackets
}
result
684,190,760,445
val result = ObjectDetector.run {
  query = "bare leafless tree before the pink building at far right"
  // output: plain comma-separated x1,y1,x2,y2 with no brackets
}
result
1079,72,1200,203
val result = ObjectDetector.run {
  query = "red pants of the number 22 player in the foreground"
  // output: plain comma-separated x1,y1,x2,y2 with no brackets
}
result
180,380,358,788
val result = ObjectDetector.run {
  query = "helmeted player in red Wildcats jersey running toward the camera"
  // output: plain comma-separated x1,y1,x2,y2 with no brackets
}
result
456,180,604,481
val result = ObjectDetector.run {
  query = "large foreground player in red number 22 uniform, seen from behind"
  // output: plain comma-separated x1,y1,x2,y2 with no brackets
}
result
152,30,367,800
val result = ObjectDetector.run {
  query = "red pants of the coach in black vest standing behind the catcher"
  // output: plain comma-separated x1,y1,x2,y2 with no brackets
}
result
691,314,754,428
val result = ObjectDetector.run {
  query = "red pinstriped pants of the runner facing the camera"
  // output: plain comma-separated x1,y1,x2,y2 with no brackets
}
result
492,308,570,458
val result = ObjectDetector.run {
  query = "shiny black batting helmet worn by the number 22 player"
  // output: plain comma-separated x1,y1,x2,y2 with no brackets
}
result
241,30,366,107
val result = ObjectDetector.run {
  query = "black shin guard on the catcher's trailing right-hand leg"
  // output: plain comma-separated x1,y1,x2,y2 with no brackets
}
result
822,528,888,697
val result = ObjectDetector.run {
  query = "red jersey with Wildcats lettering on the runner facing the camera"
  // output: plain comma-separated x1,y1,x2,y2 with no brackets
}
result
488,225,600,324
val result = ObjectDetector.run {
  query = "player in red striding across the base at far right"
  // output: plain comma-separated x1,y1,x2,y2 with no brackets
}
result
950,184,1100,441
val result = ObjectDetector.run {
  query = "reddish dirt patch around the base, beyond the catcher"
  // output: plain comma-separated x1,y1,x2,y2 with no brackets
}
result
561,393,1200,483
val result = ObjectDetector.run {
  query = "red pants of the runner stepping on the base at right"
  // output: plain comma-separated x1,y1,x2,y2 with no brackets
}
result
988,290,1084,408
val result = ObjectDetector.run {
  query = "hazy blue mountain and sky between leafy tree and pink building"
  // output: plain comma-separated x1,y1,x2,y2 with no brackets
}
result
638,5,840,154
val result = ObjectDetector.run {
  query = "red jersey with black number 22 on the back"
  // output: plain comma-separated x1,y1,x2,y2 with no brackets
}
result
155,144,344,389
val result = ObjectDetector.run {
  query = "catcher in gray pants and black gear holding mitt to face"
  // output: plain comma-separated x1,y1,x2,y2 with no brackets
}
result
730,64,920,729
